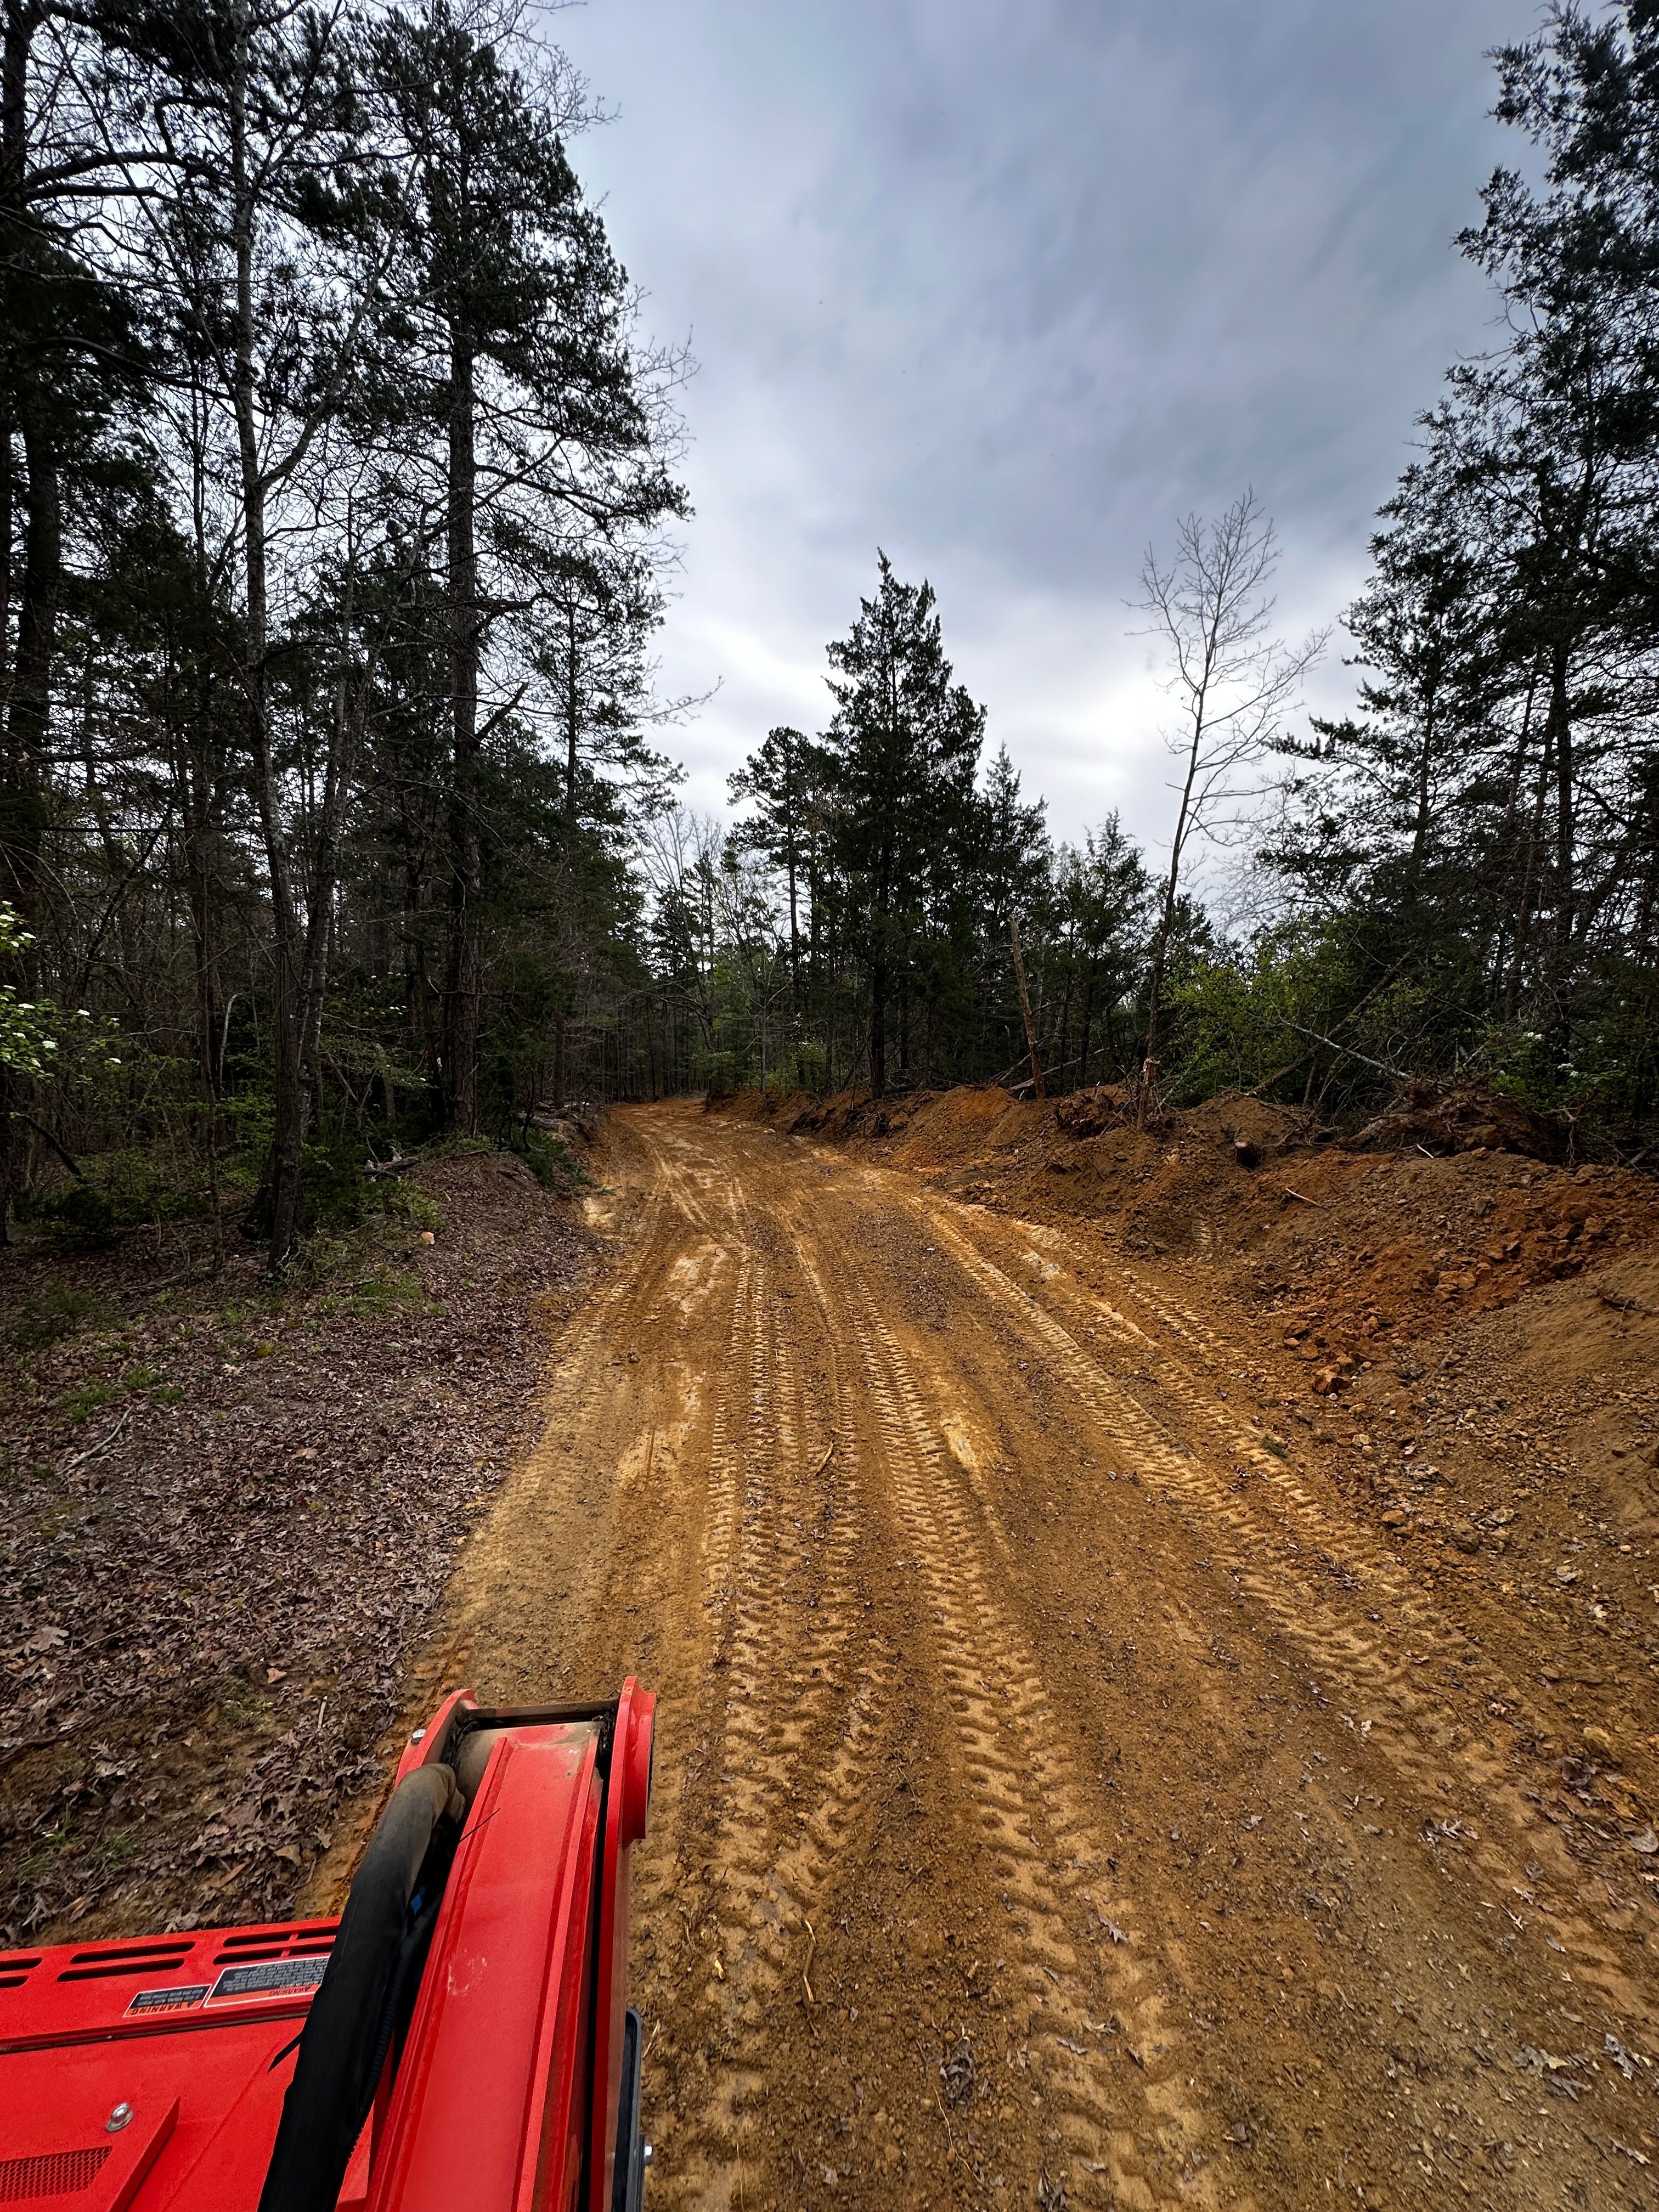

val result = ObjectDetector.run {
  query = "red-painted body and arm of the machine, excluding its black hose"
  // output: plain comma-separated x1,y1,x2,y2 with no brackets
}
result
0,1681,654,2212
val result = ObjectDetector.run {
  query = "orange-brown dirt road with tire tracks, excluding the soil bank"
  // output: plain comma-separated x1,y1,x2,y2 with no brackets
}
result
396,1106,1659,2208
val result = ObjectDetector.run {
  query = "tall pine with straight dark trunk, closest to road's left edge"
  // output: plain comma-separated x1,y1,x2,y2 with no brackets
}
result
371,0,686,1130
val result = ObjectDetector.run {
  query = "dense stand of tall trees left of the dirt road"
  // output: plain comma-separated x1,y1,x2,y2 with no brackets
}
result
0,0,686,1259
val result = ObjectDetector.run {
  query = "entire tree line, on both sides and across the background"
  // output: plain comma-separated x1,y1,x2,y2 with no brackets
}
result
0,0,1659,1261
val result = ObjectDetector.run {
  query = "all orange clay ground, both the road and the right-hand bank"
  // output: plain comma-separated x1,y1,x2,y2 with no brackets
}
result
325,1091,1659,2212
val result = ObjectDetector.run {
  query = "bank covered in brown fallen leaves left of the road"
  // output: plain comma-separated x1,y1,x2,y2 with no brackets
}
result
0,1153,591,1949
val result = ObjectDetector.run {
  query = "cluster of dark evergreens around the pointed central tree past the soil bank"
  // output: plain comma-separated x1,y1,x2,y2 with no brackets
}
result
708,560,1148,1091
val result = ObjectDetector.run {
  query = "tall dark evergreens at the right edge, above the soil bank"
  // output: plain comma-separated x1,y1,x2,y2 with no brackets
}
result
1263,0,1659,1132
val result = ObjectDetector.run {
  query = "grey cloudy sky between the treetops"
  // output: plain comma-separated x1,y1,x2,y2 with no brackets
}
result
562,0,1537,845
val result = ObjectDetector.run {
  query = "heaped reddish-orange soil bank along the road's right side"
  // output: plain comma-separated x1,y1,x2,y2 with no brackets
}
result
710,1086,1659,1389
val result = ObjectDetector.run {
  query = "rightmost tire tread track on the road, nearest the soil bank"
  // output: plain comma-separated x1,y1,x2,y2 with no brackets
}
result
924,1201,1650,2024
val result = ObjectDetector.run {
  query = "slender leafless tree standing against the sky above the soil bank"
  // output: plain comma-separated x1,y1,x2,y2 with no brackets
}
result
1137,489,1329,1124
